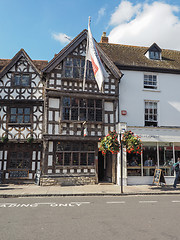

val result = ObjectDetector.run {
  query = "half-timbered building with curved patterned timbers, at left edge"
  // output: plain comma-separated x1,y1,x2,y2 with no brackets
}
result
0,49,47,182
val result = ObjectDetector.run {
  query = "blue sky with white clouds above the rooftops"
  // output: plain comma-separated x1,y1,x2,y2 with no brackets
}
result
0,0,180,61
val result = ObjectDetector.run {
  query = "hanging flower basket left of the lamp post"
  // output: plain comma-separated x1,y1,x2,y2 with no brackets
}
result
99,131,120,155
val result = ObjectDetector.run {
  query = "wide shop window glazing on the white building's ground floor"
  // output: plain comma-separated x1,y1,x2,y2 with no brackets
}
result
127,143,180,176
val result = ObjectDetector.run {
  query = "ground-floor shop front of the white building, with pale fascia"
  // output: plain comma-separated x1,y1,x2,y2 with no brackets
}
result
127,128,180,185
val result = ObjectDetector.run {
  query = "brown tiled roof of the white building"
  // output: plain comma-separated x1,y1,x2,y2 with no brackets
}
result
98,43,180,71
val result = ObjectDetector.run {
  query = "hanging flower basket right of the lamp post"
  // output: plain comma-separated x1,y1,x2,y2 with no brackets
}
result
121,131,142,154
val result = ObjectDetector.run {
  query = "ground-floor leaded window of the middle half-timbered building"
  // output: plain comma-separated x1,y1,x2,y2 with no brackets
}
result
56,141,96,166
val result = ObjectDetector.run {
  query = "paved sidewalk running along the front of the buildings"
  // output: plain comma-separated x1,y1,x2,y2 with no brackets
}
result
0,184,180,198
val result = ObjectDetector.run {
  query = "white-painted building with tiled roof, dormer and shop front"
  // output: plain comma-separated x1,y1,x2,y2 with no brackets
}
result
99,41,180,184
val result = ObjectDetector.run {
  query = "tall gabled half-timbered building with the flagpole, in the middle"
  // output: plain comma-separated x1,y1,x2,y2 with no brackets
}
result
41,30,121,185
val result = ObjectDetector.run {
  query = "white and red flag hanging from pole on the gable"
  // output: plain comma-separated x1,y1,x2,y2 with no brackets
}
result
84,17,109,91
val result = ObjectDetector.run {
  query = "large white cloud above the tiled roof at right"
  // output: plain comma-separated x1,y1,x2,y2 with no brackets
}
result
109,1,180,50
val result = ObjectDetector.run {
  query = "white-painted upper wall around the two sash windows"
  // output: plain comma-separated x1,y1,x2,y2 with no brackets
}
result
120,71,180,127
